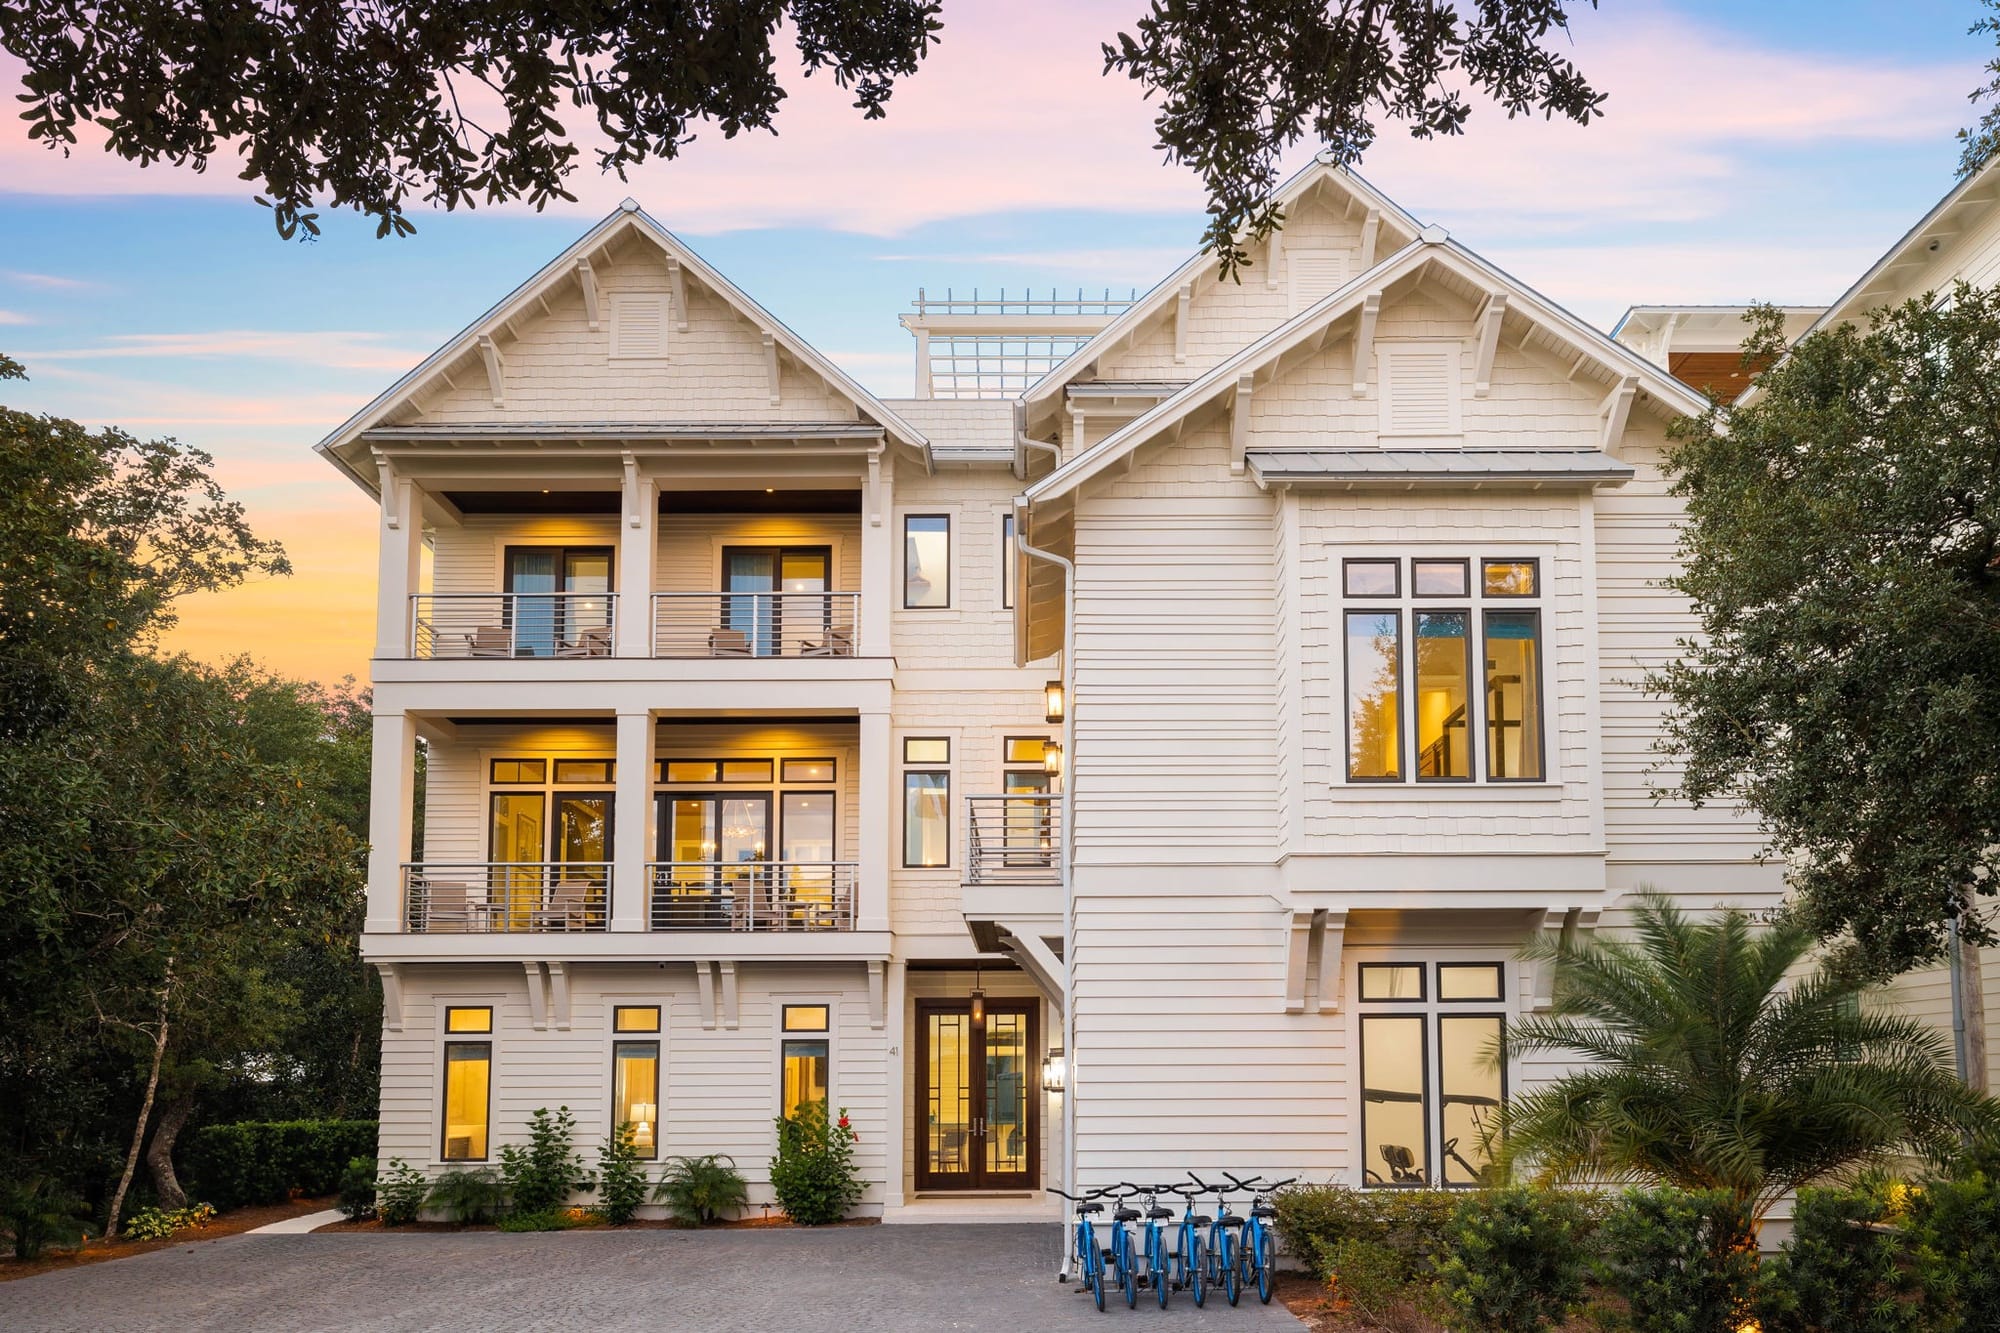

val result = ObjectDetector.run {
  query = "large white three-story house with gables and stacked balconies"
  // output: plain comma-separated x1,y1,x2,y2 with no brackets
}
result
320,166,1780,1217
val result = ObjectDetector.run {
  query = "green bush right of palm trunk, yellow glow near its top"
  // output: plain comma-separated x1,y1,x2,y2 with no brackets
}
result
1758,1181,1942,1333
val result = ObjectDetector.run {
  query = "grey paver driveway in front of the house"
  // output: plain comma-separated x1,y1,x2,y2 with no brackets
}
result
0,1225,1300,1333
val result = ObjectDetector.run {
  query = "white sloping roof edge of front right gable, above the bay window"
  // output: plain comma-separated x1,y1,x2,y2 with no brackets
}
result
1026,228,1708,504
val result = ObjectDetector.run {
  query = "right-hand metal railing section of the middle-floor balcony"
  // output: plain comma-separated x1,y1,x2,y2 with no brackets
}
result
646,861,860,933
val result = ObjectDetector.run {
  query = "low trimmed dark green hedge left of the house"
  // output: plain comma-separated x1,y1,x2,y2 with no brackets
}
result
182,1121,376,1209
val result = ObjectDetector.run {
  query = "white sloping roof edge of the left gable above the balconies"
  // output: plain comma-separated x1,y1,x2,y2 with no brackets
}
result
312,198,932,494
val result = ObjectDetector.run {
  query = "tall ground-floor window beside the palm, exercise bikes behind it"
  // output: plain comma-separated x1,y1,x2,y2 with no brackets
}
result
1358,963,1506,1189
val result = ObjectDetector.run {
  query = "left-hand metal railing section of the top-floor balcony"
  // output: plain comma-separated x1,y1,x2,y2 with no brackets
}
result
410,592,618,660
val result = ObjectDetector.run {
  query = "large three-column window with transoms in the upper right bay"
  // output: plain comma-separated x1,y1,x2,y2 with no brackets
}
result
1340,556,1544,783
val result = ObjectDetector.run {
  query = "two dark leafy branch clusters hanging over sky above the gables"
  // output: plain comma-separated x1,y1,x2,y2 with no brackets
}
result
0,0,1604,268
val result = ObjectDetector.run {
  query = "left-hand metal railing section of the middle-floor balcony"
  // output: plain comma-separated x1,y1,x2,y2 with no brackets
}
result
402,861,612,935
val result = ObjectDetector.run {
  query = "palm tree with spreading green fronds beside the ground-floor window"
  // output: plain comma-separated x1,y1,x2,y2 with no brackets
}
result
1504,895,2000,1221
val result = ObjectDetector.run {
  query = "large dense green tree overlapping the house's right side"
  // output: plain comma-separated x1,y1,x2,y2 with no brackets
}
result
1650,284,2000,973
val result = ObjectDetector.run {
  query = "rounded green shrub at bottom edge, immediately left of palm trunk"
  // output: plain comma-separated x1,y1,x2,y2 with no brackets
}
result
1604,1189,1756,1333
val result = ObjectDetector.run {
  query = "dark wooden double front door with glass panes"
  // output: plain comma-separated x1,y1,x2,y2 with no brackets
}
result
912,999,1042,1189
